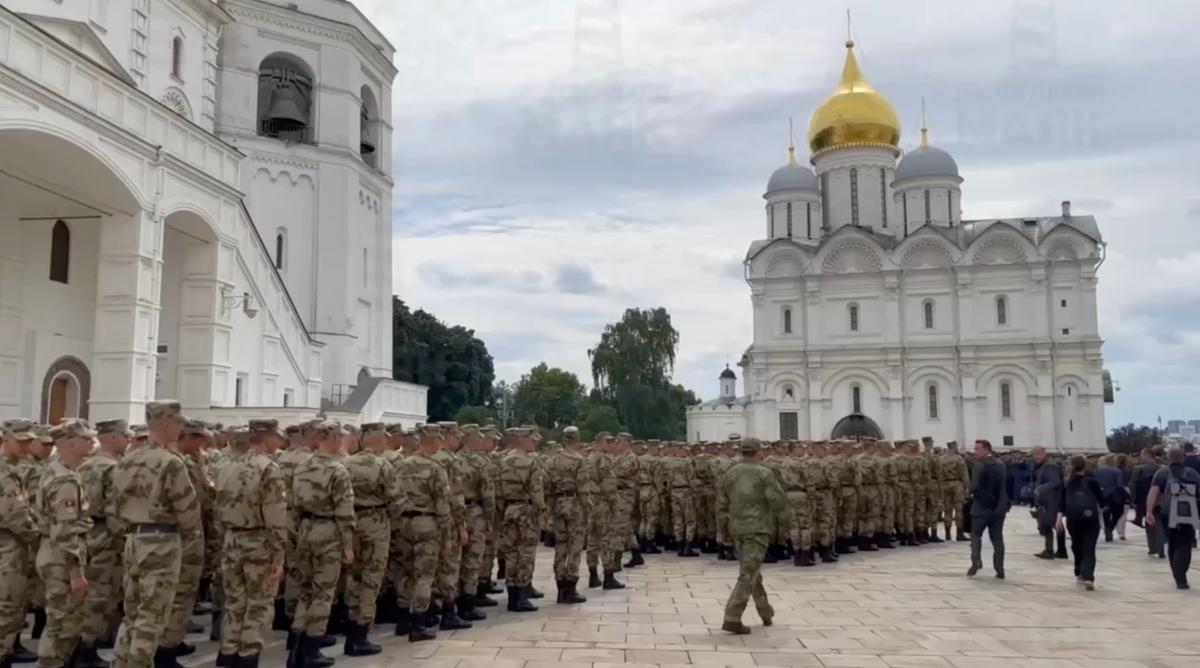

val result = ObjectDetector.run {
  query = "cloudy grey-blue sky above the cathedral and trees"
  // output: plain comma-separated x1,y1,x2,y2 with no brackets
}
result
358,0,1200,426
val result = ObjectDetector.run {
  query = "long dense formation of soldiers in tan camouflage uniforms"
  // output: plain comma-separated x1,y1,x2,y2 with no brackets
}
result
0,402,970,668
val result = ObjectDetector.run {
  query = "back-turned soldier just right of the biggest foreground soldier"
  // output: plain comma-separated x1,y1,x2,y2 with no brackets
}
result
214,420,288,668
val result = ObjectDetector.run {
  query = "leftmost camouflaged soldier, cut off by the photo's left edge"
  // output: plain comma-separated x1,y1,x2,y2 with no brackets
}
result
0,420,37,666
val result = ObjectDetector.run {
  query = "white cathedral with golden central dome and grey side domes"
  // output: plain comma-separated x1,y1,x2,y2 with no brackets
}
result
688,42,1110,451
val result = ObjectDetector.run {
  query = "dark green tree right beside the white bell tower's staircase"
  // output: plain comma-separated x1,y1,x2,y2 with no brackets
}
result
391,297,496,421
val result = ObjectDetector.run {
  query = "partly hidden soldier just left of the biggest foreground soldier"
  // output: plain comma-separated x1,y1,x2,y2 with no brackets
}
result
78,420,133,668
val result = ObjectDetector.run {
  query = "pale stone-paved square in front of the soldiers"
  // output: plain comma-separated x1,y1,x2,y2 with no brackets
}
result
35,508,1200,668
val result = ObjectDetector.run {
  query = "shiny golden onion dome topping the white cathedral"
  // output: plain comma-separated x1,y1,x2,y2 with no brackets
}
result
809,41,900,154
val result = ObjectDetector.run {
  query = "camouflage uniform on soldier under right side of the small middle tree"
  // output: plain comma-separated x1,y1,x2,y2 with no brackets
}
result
546,434,589,592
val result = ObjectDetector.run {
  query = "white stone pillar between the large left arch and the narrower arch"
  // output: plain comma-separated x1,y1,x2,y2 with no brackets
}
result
89,211,163,423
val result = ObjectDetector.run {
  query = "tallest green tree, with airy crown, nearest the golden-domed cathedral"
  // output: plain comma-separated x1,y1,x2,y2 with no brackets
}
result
588,307,697,439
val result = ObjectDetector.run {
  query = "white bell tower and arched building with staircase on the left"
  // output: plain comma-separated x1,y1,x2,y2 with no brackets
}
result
0,0,426,425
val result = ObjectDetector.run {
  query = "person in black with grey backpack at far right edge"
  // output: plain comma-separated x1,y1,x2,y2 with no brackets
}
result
1146,447,1200,589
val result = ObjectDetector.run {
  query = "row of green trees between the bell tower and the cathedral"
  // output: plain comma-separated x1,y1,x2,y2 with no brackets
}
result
392,297,700,440
